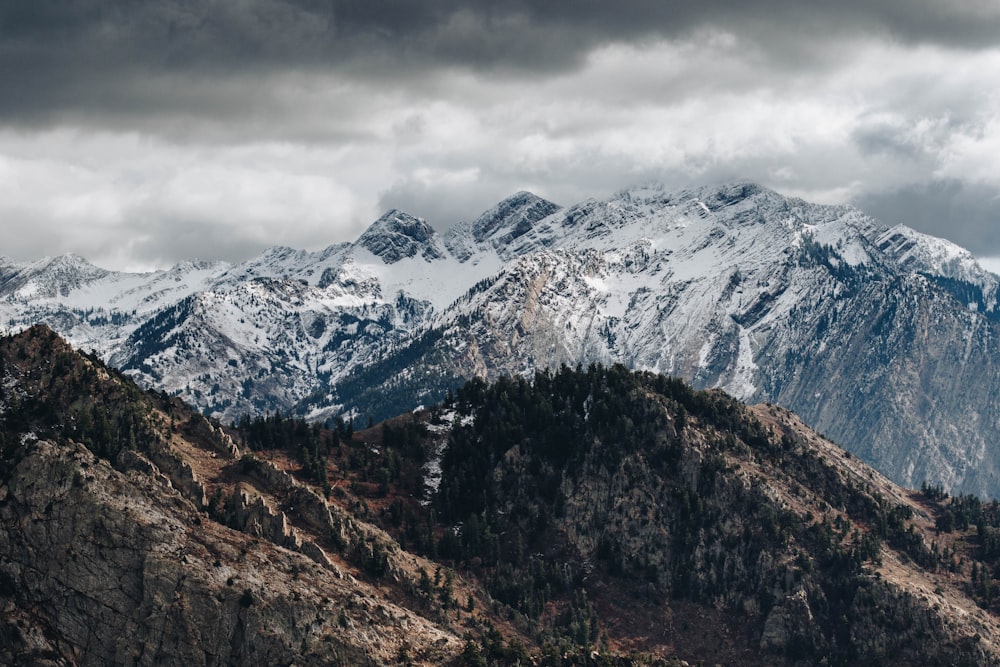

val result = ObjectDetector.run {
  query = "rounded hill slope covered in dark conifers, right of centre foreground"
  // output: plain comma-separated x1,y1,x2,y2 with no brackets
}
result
416,366,997,665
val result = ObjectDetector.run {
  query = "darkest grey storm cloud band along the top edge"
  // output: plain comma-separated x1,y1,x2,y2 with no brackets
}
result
7,0,1000,123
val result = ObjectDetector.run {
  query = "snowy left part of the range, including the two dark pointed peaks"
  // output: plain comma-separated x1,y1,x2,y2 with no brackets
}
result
0,188,572,416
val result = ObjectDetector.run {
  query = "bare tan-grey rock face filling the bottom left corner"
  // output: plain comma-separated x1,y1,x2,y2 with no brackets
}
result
0,441,457,665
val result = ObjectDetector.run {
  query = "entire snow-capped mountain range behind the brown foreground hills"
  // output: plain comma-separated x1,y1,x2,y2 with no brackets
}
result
0,183,1000,495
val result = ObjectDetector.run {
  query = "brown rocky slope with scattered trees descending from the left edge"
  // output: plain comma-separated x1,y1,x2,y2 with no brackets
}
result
0,327,459,665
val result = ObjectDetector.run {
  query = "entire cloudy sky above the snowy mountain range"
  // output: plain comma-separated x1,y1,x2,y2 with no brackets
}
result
0,0,1000,269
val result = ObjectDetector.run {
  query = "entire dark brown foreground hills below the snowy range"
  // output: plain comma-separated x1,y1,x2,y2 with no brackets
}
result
0,327,1000,665
